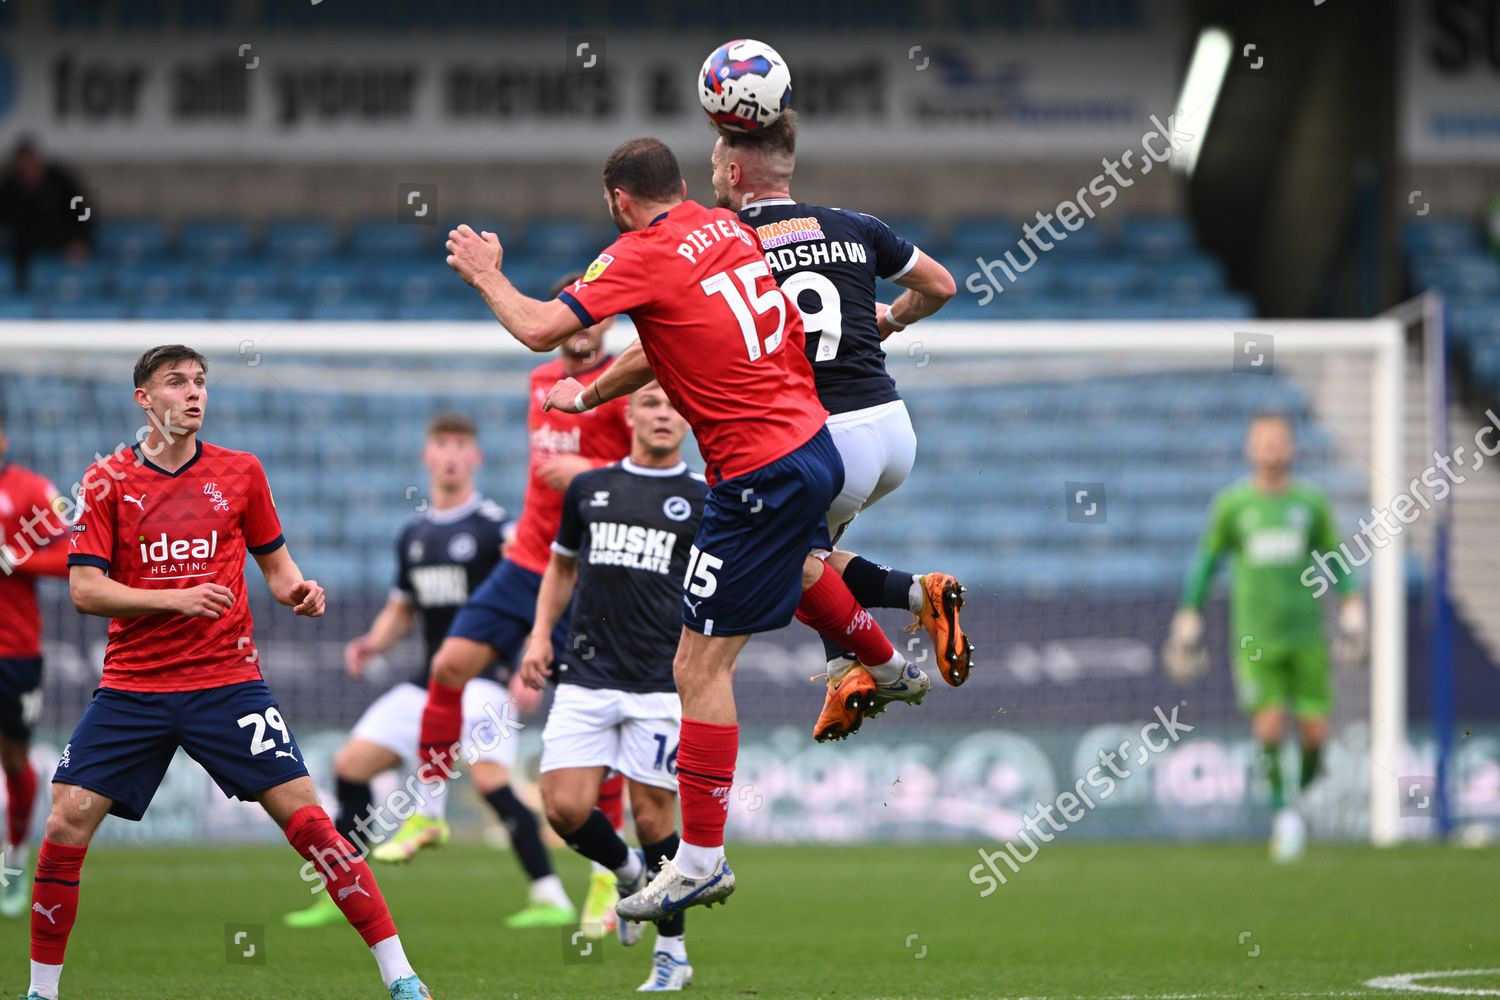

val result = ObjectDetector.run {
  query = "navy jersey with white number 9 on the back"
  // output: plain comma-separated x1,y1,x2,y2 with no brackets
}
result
740,198,918,414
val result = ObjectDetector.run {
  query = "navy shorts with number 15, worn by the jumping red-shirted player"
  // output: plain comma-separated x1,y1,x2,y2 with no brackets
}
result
683,427,843,636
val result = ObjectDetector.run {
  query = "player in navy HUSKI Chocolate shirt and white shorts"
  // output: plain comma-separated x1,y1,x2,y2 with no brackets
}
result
522,382,708,993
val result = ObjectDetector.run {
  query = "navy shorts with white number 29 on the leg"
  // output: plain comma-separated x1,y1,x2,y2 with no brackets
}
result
53,681,308,820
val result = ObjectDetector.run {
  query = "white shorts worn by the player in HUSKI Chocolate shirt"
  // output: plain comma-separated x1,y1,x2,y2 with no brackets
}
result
542,684,683,792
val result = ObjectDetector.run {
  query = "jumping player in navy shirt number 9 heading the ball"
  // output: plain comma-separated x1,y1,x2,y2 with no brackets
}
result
713,109,974,728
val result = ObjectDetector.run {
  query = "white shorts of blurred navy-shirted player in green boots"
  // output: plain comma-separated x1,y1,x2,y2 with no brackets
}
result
351,678,521,771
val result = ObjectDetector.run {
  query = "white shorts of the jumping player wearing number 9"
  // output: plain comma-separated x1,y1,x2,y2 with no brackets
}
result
828,399,917,543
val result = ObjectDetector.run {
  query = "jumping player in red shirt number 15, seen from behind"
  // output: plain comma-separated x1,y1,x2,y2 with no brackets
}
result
449,138,926,921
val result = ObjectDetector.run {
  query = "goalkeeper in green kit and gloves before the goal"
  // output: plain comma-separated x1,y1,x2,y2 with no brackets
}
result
1164,414,1367,861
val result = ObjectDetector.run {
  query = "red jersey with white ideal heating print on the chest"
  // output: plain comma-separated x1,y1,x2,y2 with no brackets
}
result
68,442,285,691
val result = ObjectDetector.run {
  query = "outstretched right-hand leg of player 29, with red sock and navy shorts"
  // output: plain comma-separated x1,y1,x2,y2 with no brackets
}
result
176,681,431,1000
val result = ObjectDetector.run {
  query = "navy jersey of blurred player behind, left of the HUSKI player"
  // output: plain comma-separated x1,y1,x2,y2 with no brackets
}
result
396,493,510,687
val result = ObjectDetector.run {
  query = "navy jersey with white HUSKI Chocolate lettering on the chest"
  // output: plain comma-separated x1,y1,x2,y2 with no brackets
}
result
552,459,708,694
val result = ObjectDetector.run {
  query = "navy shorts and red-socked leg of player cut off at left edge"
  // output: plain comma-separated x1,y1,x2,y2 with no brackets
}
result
0,657,42,919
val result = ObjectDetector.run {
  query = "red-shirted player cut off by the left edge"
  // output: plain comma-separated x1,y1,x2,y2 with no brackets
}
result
0,418,68,919
